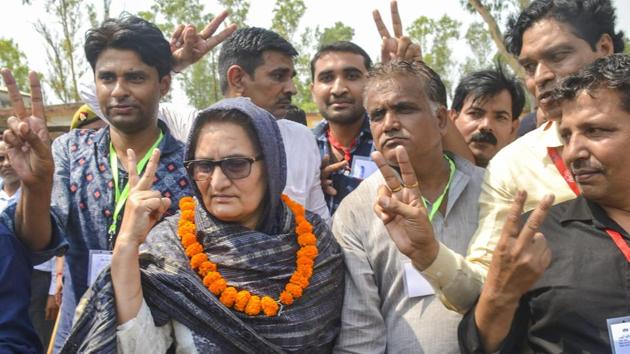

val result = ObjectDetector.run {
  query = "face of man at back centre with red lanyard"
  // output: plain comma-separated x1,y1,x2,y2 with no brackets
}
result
311,52,367,124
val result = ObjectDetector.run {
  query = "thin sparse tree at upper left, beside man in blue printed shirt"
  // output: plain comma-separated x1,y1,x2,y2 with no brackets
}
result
35,0,85,103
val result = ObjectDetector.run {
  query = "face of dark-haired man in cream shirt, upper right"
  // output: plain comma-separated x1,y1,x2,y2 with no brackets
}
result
518,18,613,118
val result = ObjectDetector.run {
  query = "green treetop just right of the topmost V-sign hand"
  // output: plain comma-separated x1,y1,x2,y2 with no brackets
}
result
407,15,461,92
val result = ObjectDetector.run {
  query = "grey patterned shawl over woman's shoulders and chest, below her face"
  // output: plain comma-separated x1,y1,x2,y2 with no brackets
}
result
62,202,344,353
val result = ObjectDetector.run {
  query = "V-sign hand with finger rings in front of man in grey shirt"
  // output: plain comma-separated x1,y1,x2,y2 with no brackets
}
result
371,146,439,270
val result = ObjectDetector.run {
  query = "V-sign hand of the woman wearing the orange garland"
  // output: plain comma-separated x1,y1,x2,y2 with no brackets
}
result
116,149,171,246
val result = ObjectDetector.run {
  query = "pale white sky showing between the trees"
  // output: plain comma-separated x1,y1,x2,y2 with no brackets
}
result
0,0,630,103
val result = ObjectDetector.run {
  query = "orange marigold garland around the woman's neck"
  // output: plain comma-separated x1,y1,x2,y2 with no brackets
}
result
177,194,319,317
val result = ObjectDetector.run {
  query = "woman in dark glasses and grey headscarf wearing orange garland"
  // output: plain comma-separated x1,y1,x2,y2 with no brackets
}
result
65,98,344,353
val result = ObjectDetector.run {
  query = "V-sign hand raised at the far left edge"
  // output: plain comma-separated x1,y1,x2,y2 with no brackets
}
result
1,69,54,189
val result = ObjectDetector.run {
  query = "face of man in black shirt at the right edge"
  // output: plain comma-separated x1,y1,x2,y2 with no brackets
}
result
560,89,630,206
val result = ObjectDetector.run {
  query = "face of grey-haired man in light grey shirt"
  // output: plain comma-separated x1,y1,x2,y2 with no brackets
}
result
365,75,447,165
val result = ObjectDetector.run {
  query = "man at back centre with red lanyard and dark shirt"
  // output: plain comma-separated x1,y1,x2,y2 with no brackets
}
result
311,41,377,214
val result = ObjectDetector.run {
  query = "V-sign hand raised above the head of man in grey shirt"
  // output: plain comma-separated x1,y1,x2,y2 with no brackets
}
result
372,1,422,64
